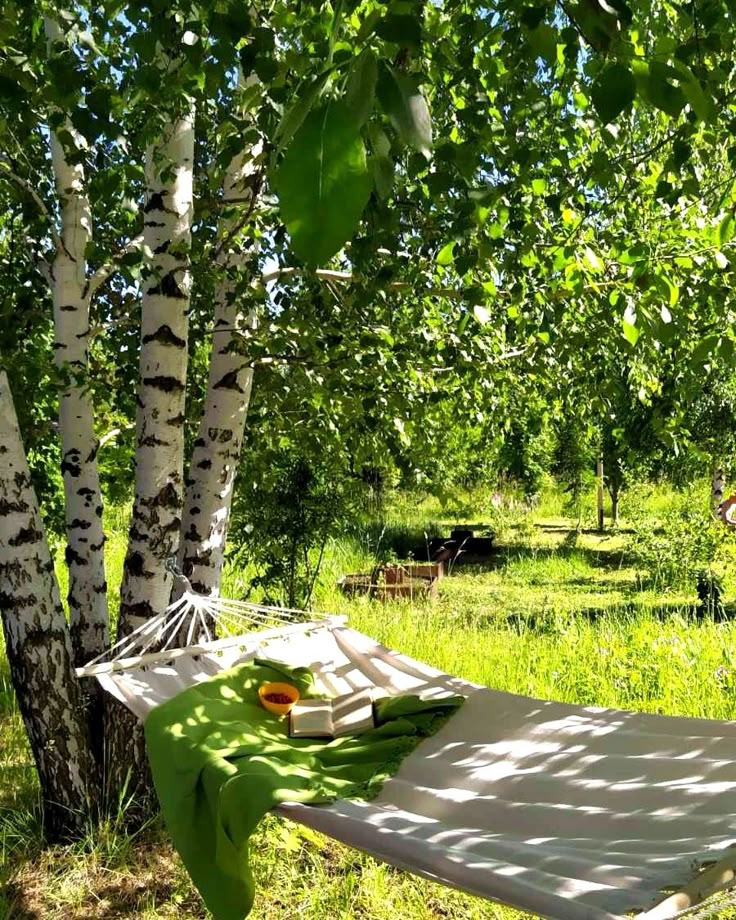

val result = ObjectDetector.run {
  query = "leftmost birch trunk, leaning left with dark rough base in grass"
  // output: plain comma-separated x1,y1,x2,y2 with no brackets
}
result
0,371,98,839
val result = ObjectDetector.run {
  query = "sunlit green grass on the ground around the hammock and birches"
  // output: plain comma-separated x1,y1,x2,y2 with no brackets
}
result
0,488,736,920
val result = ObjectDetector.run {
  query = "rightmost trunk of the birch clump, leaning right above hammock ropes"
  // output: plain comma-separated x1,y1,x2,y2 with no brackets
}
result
179,145,261,595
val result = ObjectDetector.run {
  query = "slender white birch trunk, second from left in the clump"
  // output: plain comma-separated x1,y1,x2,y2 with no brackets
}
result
45,18,109,665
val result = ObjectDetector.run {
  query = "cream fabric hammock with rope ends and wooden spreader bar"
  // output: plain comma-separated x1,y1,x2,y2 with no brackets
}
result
77,591,736,920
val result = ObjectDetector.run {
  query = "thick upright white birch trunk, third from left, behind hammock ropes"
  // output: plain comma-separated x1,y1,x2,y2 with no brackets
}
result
120,106,194,632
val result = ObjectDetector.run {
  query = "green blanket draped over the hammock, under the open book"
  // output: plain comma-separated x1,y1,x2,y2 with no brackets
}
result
145,659,463,920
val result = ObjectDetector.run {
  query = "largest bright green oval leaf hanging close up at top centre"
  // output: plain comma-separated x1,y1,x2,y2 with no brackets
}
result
275,102,372,264
